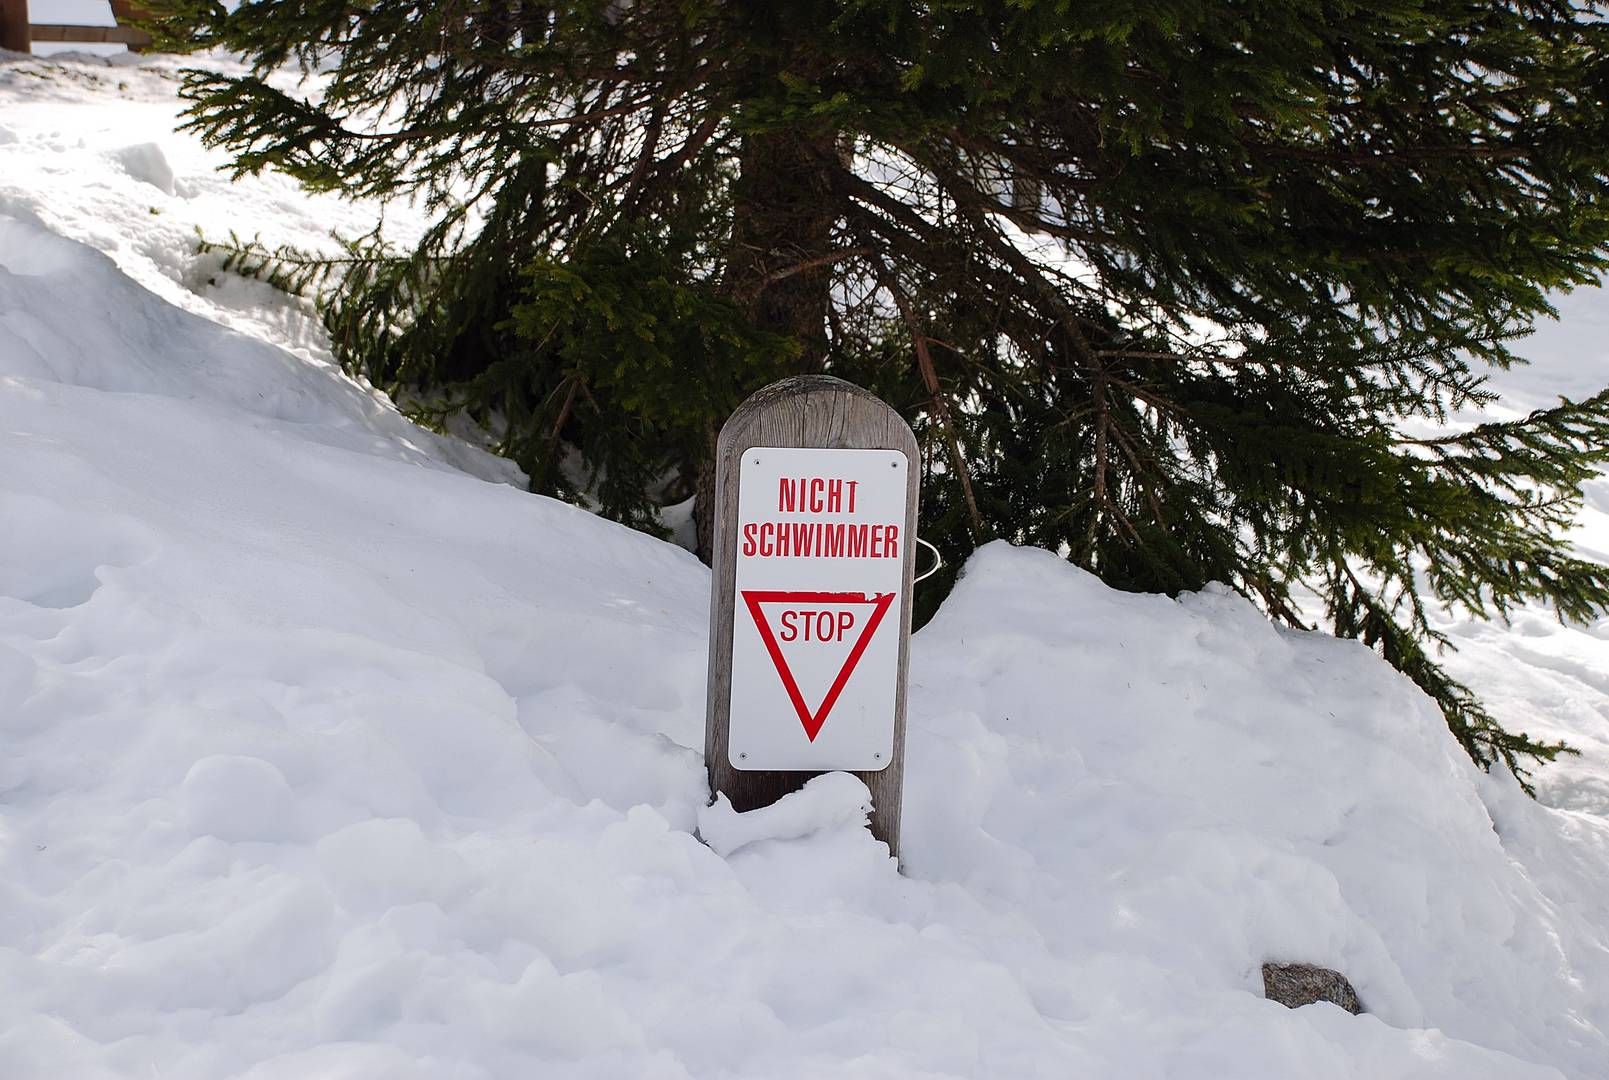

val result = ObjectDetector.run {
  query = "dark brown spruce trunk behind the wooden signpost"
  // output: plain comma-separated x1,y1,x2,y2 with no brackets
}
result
693,129,840,563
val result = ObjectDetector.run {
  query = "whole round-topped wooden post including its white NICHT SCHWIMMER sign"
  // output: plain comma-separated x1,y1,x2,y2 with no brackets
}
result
705,375,920,858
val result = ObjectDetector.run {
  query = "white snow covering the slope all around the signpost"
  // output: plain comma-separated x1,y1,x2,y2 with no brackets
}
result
0,52,1609,1080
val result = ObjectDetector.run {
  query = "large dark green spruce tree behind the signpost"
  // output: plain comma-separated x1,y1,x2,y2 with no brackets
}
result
158,0,1609,781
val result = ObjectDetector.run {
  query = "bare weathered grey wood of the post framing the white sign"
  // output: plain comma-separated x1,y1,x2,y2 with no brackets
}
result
705,375,922,858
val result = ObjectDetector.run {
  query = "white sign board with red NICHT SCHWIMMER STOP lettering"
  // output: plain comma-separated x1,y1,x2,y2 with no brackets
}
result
727,446,916,771
